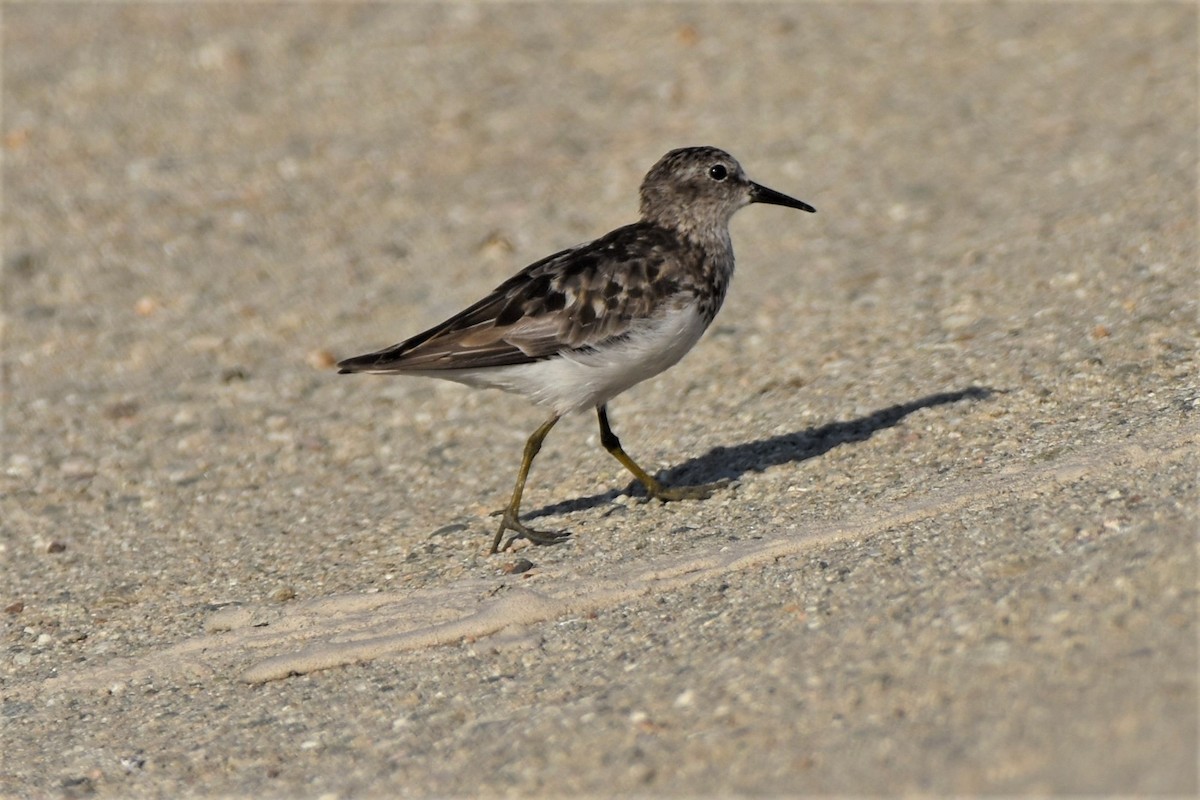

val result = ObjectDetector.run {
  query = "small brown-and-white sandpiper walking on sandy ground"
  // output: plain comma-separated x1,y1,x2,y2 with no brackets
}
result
337,148,816,553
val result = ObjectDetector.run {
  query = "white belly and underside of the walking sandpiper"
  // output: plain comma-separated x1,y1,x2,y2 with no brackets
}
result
432,306,707,414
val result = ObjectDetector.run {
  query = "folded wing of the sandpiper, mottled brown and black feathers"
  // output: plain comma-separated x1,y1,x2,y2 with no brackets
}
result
337,223,689,372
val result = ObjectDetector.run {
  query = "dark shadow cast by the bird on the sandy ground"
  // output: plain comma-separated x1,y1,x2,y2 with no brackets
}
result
524,386,1004,519
